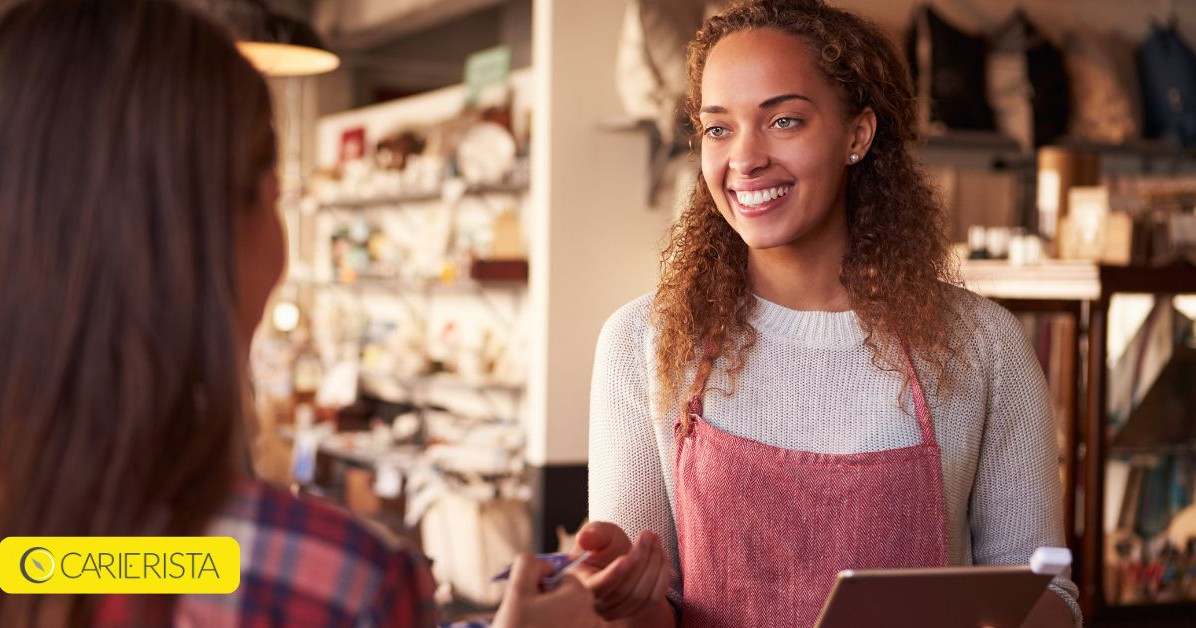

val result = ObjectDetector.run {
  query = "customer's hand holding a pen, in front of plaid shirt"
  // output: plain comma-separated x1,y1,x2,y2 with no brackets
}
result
492,554,603,628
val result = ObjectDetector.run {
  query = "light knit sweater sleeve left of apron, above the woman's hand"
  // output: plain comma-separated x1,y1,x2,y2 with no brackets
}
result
588,297,679,591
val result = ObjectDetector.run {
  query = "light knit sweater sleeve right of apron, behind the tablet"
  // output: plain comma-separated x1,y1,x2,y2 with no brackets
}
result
970,303,1081,627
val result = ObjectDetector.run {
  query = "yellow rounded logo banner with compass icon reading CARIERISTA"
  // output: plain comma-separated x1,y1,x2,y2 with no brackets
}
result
0,536,240,593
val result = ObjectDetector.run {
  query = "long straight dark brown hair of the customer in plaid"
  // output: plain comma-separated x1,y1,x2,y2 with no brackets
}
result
0,0,275,626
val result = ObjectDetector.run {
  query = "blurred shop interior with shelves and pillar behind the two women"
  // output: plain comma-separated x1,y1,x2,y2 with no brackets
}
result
72,0,1196,626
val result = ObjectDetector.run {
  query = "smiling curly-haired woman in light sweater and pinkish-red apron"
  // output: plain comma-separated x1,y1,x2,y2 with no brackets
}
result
578,0,1079,626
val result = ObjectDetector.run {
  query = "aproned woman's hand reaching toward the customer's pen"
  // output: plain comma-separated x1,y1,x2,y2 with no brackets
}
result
575,522,671,620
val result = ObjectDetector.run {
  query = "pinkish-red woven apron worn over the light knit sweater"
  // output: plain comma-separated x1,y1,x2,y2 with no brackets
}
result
673,356,947,627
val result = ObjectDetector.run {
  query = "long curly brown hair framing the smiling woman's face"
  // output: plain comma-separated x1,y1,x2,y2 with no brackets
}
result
652,0,957,418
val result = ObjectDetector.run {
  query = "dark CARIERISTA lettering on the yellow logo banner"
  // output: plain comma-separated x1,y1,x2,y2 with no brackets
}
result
62,551,220,580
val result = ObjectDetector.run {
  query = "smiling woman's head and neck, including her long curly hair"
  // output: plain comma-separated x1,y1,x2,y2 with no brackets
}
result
669,2,954,401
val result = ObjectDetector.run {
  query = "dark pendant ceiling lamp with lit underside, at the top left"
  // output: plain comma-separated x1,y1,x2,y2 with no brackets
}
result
222,0,341,77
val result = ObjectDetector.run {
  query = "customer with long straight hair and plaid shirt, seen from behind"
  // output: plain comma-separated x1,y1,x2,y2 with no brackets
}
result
0,0,594,626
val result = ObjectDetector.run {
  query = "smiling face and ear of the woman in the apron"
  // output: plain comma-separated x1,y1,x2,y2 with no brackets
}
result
700,29,874,249
